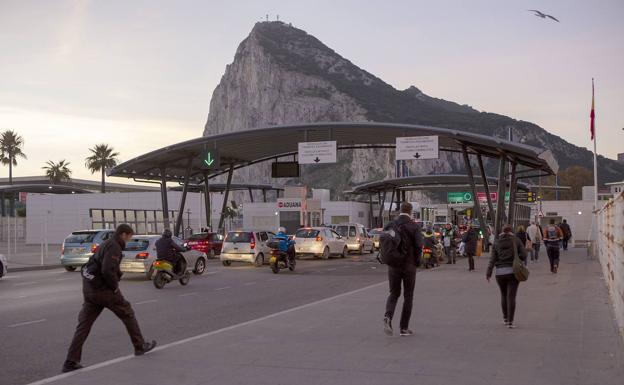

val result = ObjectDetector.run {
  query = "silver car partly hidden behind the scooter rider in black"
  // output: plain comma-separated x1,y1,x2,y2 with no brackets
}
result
119,235,206,279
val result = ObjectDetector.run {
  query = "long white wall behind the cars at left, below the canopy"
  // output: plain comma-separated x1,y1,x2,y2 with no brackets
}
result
26,191,223,244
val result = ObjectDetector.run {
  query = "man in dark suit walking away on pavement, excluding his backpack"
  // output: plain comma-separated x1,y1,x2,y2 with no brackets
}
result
384,202,423,336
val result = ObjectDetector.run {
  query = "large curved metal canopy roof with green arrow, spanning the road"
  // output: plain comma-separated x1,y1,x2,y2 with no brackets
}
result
108,122,558,183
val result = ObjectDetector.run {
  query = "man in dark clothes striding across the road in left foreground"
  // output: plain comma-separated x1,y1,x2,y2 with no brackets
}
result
63,224,156,373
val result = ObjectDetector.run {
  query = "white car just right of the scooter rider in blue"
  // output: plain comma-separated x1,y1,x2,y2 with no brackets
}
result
293,227,349,259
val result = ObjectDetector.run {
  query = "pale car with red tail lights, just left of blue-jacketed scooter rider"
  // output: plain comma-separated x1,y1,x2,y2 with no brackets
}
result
219,230,275,267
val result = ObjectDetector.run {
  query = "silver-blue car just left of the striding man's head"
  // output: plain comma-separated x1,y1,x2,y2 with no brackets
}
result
61,230,115,271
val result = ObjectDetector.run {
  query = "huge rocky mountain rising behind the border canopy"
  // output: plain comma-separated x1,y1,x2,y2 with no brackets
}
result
204,22,624,193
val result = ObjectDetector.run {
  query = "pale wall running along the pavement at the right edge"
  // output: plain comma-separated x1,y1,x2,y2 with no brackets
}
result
597,193,624,337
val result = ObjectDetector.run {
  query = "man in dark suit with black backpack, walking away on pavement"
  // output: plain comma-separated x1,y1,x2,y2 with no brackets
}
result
379,202,423,336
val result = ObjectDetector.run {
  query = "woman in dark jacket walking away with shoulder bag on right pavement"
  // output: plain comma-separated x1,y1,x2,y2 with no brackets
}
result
485,225,527,329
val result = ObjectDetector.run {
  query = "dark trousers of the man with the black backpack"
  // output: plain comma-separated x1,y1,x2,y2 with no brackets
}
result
386,265,416,329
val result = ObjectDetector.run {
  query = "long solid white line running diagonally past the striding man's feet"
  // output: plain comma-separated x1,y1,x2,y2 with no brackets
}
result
27,280,388,385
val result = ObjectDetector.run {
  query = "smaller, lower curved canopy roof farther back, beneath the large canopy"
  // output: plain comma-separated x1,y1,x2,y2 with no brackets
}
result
348,174,529,194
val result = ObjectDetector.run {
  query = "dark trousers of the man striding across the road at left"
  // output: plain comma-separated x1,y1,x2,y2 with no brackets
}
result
67,290,145,362
